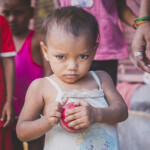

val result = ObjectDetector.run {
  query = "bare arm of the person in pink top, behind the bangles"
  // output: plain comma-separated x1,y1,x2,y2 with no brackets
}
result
117,0,137,26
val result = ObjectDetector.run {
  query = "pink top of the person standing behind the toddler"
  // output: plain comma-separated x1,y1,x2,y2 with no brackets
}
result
60,0,129,60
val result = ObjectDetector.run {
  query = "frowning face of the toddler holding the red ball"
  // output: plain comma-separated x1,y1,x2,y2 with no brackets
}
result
41,27,96,83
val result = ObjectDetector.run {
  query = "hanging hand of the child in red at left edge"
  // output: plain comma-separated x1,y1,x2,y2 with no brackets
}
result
1,102,14,127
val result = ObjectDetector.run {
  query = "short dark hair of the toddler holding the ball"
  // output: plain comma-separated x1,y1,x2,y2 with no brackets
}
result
42,6,99,47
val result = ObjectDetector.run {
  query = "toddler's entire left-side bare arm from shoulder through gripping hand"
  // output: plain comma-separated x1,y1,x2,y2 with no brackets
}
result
17,79,65,141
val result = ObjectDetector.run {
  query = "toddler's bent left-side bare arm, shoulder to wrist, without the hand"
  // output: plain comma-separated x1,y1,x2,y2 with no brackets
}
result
16,79,50,141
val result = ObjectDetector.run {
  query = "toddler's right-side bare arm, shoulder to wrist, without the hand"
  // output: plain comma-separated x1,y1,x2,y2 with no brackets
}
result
96,71,128,124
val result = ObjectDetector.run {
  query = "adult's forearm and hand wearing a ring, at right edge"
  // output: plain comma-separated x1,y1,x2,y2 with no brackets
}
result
132,0,150,73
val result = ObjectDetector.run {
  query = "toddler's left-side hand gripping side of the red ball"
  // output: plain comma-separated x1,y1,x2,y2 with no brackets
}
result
45,98,68,127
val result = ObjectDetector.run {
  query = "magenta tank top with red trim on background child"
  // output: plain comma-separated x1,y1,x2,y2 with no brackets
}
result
15,31,43,115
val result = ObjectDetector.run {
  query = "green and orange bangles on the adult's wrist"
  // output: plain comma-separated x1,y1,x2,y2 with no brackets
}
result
132,16,150,29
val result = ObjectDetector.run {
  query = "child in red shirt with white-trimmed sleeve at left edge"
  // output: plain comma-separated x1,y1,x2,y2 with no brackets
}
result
0,16,16,150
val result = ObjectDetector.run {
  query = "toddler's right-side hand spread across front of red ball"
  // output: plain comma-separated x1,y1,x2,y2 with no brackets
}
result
65,100,97,129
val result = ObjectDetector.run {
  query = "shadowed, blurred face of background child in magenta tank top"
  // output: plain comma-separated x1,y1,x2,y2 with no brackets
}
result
1,0,33,35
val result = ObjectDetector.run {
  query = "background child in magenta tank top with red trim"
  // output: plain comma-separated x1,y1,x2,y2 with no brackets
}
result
1,0,51,150
